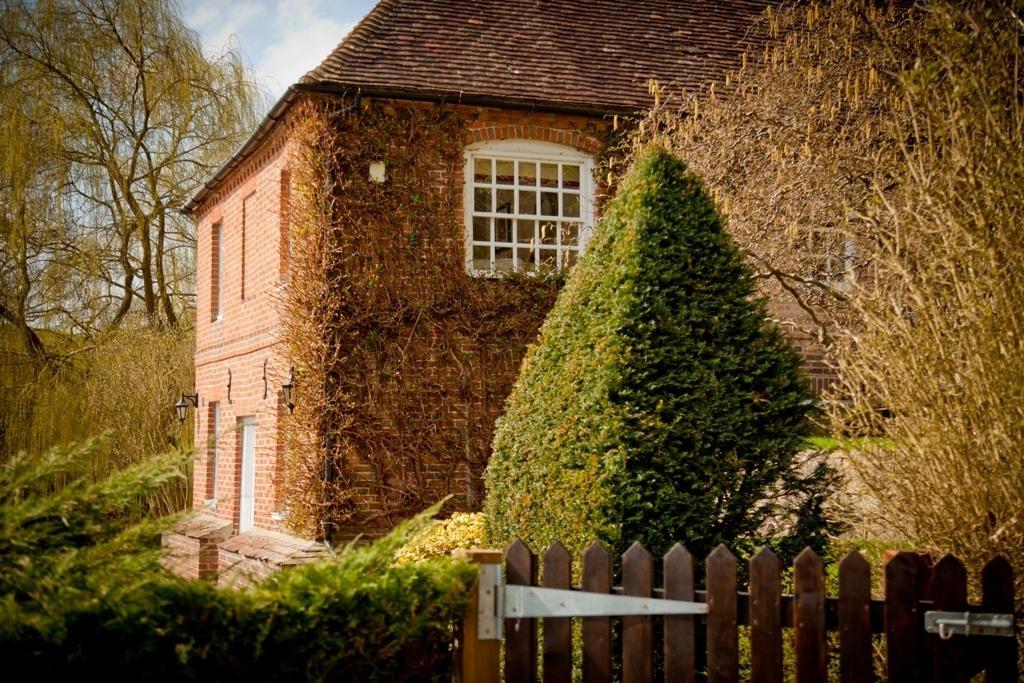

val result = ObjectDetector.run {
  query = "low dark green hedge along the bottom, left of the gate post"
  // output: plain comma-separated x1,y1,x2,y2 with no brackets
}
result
0,560,472,681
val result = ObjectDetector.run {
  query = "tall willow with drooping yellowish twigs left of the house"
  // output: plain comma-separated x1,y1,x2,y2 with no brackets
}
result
0,0,263,342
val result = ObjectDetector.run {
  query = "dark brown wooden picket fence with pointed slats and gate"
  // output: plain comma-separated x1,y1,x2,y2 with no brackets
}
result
457,542,1018,683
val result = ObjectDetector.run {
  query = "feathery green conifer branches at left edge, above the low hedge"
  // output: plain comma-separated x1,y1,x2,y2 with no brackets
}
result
0,439,188,602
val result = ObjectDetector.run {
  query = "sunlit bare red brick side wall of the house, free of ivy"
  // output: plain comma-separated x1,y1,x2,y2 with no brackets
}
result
194,126,290,528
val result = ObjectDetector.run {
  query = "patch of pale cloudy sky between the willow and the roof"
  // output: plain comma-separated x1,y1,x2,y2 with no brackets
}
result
181,0,376,100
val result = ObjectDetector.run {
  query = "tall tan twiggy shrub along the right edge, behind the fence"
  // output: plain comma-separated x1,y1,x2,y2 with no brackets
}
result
834,3,1024,575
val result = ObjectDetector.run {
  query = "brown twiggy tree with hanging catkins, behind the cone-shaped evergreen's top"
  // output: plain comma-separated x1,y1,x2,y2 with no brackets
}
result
627,0,912,340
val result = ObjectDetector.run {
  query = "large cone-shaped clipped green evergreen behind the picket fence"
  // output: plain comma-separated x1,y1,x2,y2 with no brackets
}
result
485,148,836,556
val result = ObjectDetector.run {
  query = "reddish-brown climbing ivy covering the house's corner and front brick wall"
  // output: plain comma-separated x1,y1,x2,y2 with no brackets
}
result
285,100,561,538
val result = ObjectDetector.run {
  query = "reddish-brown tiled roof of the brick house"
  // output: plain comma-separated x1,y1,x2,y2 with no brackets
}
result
300,0,777,111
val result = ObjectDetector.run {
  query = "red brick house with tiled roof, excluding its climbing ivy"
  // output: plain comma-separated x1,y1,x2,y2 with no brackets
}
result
164,0,824,582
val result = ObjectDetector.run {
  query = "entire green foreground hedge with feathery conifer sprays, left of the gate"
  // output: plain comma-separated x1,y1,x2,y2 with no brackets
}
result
0,445,475,681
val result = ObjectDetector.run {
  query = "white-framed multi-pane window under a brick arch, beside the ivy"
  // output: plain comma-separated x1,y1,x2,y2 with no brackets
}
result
463,140,594,275
